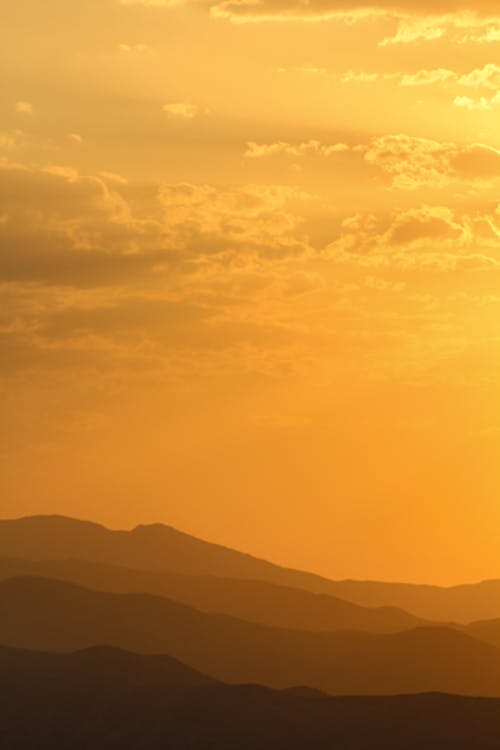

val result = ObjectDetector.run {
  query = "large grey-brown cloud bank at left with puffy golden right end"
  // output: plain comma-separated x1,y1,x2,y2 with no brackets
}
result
0,163,310,287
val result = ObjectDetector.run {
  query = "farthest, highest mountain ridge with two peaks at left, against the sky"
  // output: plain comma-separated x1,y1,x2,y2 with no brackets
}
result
0,516,500,623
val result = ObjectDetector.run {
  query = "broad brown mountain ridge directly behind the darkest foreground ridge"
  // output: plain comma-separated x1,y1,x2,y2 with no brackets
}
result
0,578,500,696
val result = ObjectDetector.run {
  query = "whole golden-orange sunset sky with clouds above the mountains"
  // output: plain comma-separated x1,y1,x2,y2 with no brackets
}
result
0,0,500,584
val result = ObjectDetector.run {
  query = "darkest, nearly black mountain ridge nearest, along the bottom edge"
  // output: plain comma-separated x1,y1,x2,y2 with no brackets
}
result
0,648,500,750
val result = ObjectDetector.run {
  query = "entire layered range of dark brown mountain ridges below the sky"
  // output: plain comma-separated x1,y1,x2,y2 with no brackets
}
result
0,516,500,750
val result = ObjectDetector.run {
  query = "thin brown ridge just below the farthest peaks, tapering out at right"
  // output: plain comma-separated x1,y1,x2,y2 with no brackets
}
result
0,559,425,633
